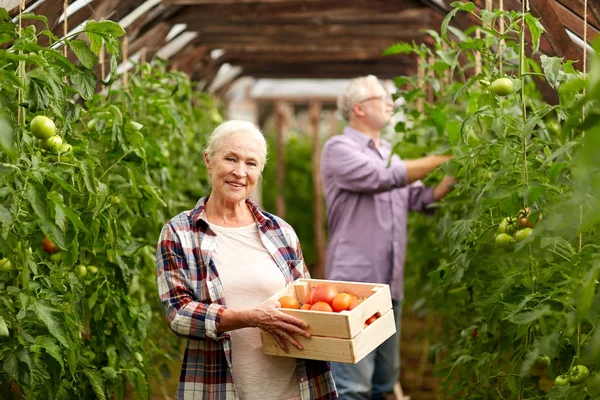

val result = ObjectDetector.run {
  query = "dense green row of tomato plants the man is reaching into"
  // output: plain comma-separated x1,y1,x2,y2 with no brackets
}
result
389,2,600,400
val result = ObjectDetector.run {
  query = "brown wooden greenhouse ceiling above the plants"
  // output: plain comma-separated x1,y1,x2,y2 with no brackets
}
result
0,0,600,97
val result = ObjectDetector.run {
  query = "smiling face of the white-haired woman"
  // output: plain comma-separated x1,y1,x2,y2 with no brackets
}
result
204,132,264,203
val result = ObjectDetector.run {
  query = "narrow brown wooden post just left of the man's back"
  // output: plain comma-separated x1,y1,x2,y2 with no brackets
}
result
308,101,326,279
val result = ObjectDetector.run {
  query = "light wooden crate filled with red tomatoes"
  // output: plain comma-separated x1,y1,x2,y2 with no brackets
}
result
261,279,396,364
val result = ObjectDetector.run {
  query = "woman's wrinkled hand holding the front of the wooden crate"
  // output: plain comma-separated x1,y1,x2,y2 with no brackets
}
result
249,300,310,353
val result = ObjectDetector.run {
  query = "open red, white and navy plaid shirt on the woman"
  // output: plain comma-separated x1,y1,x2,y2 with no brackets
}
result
156,197,337,400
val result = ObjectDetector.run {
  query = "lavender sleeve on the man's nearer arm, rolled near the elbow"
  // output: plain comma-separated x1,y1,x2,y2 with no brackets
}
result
321,136,408,193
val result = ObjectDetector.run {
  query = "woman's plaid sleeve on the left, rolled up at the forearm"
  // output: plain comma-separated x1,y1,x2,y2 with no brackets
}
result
156,224,225,340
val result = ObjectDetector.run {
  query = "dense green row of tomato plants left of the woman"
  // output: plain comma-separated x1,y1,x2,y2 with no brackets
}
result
0,9,218,399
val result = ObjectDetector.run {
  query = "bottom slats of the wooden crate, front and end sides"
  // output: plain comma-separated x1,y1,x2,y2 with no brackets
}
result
260,310,396,364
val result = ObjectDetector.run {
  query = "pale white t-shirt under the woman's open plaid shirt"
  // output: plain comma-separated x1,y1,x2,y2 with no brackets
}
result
209,224,300,400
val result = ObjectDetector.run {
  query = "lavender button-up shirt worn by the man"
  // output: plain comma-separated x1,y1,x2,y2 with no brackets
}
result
321,127,434,300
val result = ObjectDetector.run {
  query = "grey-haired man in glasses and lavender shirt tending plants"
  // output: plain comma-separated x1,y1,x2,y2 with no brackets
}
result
321,75,455,400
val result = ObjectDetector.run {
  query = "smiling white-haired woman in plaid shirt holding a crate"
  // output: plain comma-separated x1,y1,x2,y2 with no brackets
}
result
156,121,337,400
